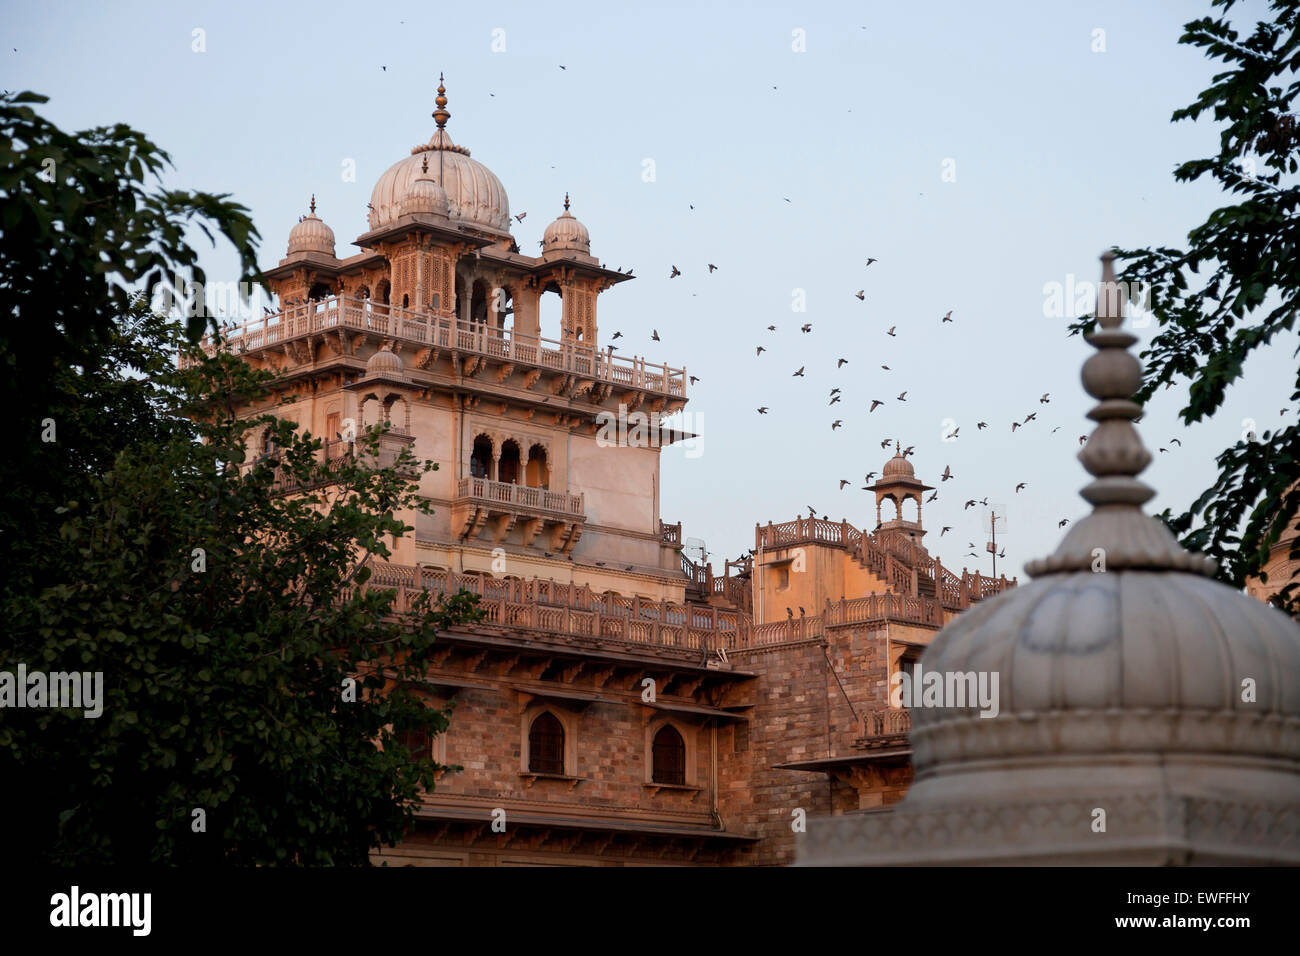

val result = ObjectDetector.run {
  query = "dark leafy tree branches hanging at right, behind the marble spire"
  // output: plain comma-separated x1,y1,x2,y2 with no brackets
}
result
1070,0,1300,614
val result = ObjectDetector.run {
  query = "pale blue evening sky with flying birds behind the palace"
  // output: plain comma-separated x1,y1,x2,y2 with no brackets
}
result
0,0,1296,580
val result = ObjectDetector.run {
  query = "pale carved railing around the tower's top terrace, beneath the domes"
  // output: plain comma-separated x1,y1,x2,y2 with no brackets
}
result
189,295,686,397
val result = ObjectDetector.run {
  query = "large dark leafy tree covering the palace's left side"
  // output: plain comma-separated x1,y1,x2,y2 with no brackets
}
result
0,95,476,865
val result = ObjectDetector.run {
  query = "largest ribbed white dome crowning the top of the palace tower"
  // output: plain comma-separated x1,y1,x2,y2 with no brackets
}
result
369,130,510,235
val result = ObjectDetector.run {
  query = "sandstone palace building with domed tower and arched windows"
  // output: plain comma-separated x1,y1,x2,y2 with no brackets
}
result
207,78,1014,866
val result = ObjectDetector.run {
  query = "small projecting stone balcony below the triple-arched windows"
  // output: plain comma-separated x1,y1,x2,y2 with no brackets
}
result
451,477,586,554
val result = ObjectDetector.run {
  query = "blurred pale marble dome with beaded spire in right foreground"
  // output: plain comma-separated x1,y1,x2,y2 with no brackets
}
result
800,254,1300,865
